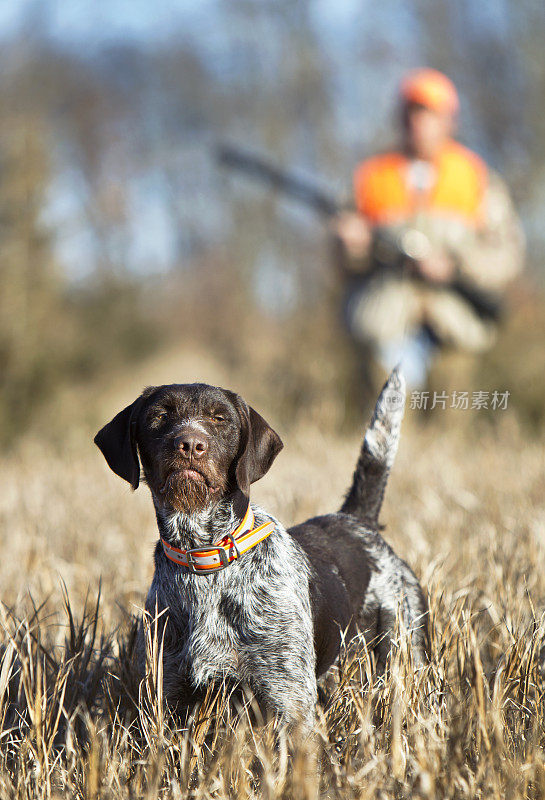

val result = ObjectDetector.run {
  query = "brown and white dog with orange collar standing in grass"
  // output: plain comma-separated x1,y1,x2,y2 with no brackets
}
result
95,371,427,725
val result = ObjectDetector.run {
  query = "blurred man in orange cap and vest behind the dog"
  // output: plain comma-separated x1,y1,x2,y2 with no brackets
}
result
335,69,524,387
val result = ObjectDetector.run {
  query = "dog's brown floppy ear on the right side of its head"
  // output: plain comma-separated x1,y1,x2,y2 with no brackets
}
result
229,392,284,497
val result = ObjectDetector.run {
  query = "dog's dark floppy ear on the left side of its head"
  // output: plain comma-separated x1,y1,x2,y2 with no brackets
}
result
94,397,142,489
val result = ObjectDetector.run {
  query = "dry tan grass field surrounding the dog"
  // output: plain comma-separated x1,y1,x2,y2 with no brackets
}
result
0,340,545,800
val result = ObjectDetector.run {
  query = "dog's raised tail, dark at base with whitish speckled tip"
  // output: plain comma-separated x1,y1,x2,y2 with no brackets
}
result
341,367,405,527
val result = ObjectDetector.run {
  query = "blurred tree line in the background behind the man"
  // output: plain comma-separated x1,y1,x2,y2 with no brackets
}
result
0,0,545,442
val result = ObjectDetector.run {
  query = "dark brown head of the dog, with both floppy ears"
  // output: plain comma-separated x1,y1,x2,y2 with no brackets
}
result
95,383,282,514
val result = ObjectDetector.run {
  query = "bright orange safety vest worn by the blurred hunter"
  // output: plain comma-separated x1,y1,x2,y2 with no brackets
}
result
354,141,488,227
